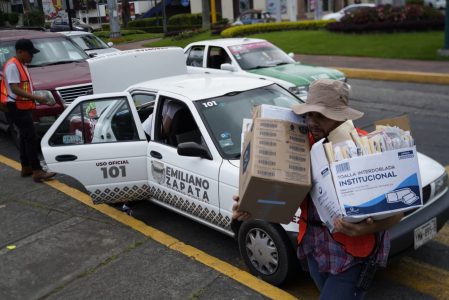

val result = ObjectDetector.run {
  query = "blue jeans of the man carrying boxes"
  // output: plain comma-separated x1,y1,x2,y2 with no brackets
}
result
307,254,365,300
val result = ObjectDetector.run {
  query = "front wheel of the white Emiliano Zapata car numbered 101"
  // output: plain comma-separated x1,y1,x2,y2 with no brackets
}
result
238,220,298,285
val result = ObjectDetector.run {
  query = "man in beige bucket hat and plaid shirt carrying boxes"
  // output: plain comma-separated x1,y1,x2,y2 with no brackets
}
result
232,79,403,300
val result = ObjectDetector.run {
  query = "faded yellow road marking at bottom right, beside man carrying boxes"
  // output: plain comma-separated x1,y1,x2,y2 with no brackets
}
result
385,257,449,299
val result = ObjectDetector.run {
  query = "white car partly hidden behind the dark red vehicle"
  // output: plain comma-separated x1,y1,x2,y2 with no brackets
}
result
61,31,120,56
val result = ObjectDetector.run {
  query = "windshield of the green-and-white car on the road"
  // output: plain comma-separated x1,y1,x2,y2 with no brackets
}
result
229,42,295,70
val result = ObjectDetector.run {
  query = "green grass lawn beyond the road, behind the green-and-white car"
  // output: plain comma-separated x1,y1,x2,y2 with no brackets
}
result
146,30,448,60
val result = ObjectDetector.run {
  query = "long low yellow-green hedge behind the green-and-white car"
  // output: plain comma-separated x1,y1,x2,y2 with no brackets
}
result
221,20,335,38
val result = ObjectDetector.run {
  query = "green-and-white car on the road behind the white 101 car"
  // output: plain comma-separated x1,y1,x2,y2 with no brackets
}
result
184,38,346,100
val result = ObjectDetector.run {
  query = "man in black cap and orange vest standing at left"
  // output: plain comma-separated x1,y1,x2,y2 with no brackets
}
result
0,39,56,182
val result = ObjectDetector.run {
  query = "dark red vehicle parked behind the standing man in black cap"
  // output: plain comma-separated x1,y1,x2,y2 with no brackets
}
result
0,30,92,141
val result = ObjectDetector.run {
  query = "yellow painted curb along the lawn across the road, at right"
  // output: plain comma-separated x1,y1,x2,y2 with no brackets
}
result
336,67,449,84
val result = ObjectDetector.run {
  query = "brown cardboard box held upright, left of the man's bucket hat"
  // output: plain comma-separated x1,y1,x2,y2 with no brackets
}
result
239,106,311,224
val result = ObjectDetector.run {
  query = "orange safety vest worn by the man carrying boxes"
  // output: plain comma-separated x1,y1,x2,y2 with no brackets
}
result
298,128,376,257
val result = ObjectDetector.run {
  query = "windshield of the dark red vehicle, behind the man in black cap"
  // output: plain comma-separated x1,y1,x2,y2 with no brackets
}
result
0,37,88,69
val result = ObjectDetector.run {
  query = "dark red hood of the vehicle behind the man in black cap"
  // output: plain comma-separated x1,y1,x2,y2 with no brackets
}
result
28,61,91,90
